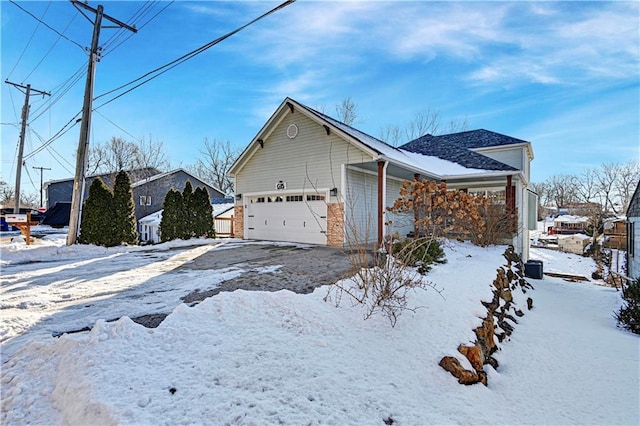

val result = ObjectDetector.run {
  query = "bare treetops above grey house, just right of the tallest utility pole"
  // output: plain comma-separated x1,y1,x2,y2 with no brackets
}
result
87,136,170,174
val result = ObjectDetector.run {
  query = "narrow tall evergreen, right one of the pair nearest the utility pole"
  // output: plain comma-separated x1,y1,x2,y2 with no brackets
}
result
113,171,138,244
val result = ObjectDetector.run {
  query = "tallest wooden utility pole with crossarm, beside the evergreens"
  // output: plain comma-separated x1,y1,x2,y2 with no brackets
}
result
67,0,138,245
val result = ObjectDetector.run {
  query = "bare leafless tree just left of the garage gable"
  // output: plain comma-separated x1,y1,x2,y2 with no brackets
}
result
187,138,240,195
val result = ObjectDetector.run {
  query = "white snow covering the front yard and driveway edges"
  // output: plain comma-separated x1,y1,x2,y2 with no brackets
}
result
0,231,640,425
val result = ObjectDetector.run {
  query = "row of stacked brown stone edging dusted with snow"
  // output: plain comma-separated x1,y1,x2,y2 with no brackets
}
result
440,246,533,386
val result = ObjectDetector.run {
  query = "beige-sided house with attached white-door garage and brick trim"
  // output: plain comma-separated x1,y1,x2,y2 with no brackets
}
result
230,98,537,260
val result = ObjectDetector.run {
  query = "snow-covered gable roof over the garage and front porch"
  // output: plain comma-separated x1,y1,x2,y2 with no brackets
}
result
230,97,527,179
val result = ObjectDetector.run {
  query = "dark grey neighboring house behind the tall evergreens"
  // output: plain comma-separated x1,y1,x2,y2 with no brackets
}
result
45,169,224,236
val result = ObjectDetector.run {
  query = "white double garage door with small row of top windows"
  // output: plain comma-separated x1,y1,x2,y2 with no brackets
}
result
247,194,327,244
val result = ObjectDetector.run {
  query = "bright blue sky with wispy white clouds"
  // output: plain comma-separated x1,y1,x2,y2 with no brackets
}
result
0,0,640,197
